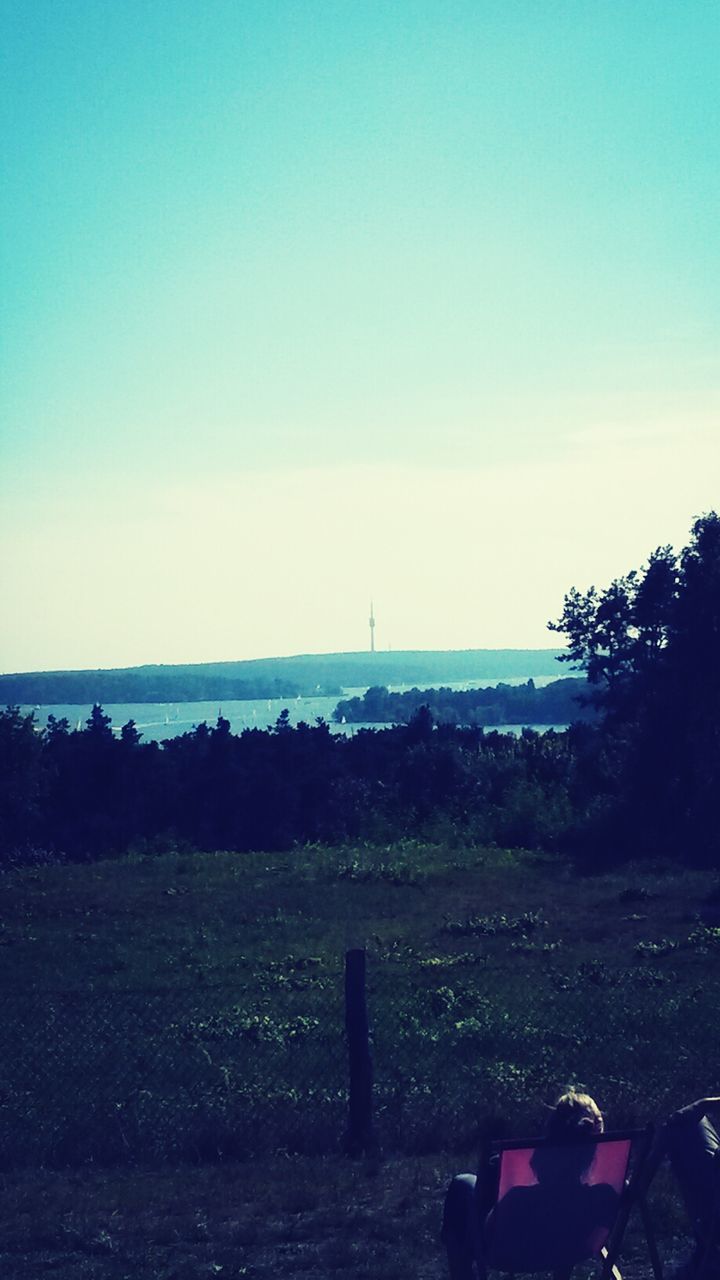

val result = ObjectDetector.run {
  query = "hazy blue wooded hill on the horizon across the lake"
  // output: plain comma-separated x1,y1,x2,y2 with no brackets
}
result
0,649,564,705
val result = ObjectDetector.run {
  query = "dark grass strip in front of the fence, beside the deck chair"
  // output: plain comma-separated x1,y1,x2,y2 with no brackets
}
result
0,1156,687,1280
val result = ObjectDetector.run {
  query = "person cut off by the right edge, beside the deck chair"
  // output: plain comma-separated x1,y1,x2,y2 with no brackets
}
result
660,1097,720,1280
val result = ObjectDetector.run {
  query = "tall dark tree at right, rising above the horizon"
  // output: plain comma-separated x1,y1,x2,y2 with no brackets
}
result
550,512,720,864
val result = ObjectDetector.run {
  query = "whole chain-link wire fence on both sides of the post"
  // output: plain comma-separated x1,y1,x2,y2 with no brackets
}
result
0,952,720,1167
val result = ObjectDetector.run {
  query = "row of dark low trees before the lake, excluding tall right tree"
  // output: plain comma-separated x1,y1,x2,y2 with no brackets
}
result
0,704,584,879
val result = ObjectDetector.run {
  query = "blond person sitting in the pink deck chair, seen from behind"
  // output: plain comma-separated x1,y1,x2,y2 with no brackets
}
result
441,1091,604,1280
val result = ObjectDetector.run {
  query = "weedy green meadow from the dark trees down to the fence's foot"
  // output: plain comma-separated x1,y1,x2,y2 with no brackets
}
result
0,844,720,1167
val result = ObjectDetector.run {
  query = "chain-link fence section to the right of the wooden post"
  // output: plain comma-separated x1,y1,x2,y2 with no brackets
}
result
369,956,720,1152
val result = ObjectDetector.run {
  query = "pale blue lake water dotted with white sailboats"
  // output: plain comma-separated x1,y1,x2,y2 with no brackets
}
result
20,676,573,742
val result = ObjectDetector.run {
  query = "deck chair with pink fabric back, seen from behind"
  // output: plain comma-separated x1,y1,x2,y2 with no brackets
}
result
478,1129,662,1280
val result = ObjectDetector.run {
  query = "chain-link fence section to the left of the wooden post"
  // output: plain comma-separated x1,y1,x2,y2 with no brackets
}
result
0,987,346,1165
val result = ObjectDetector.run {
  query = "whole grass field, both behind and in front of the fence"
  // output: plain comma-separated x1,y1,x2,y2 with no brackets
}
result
0,844,720,1280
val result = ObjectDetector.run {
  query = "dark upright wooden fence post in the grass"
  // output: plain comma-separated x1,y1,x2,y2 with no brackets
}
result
342,948,377,1156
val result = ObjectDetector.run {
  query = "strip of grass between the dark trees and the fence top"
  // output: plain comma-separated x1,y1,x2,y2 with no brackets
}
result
0,842,720,992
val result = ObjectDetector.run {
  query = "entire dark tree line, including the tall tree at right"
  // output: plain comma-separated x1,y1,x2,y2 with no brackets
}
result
0,513,720,867
